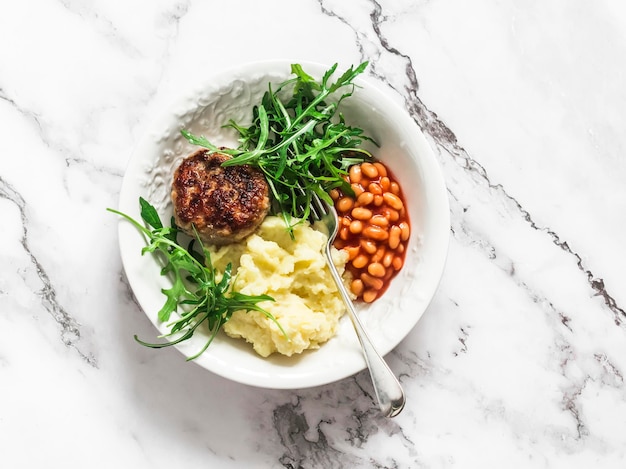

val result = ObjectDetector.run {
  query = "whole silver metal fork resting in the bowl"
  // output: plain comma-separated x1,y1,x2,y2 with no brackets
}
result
309,194,406,417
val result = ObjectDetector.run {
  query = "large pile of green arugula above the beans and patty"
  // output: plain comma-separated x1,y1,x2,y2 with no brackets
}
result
181,62,376,237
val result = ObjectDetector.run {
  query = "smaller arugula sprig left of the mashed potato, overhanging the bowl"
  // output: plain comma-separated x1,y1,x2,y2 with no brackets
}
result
107,197,288,360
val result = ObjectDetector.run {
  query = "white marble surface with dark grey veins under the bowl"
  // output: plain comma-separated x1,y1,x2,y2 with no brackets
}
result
0,0,626,468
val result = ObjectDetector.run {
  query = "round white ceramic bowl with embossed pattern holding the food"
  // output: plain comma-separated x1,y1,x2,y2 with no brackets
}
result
119,61,450,389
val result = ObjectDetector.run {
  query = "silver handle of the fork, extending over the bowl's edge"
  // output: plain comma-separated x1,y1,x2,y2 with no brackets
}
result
326,246,406,417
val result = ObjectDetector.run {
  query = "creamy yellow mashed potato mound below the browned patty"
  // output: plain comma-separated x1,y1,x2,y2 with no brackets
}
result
211,216,347,357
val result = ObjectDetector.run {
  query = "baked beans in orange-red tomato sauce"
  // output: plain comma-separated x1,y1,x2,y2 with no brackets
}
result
330,161,411,303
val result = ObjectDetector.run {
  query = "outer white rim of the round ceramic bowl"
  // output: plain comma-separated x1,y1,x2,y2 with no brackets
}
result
118,59,450,389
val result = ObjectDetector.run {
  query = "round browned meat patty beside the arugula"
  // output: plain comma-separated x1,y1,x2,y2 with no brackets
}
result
172,149,270,244
